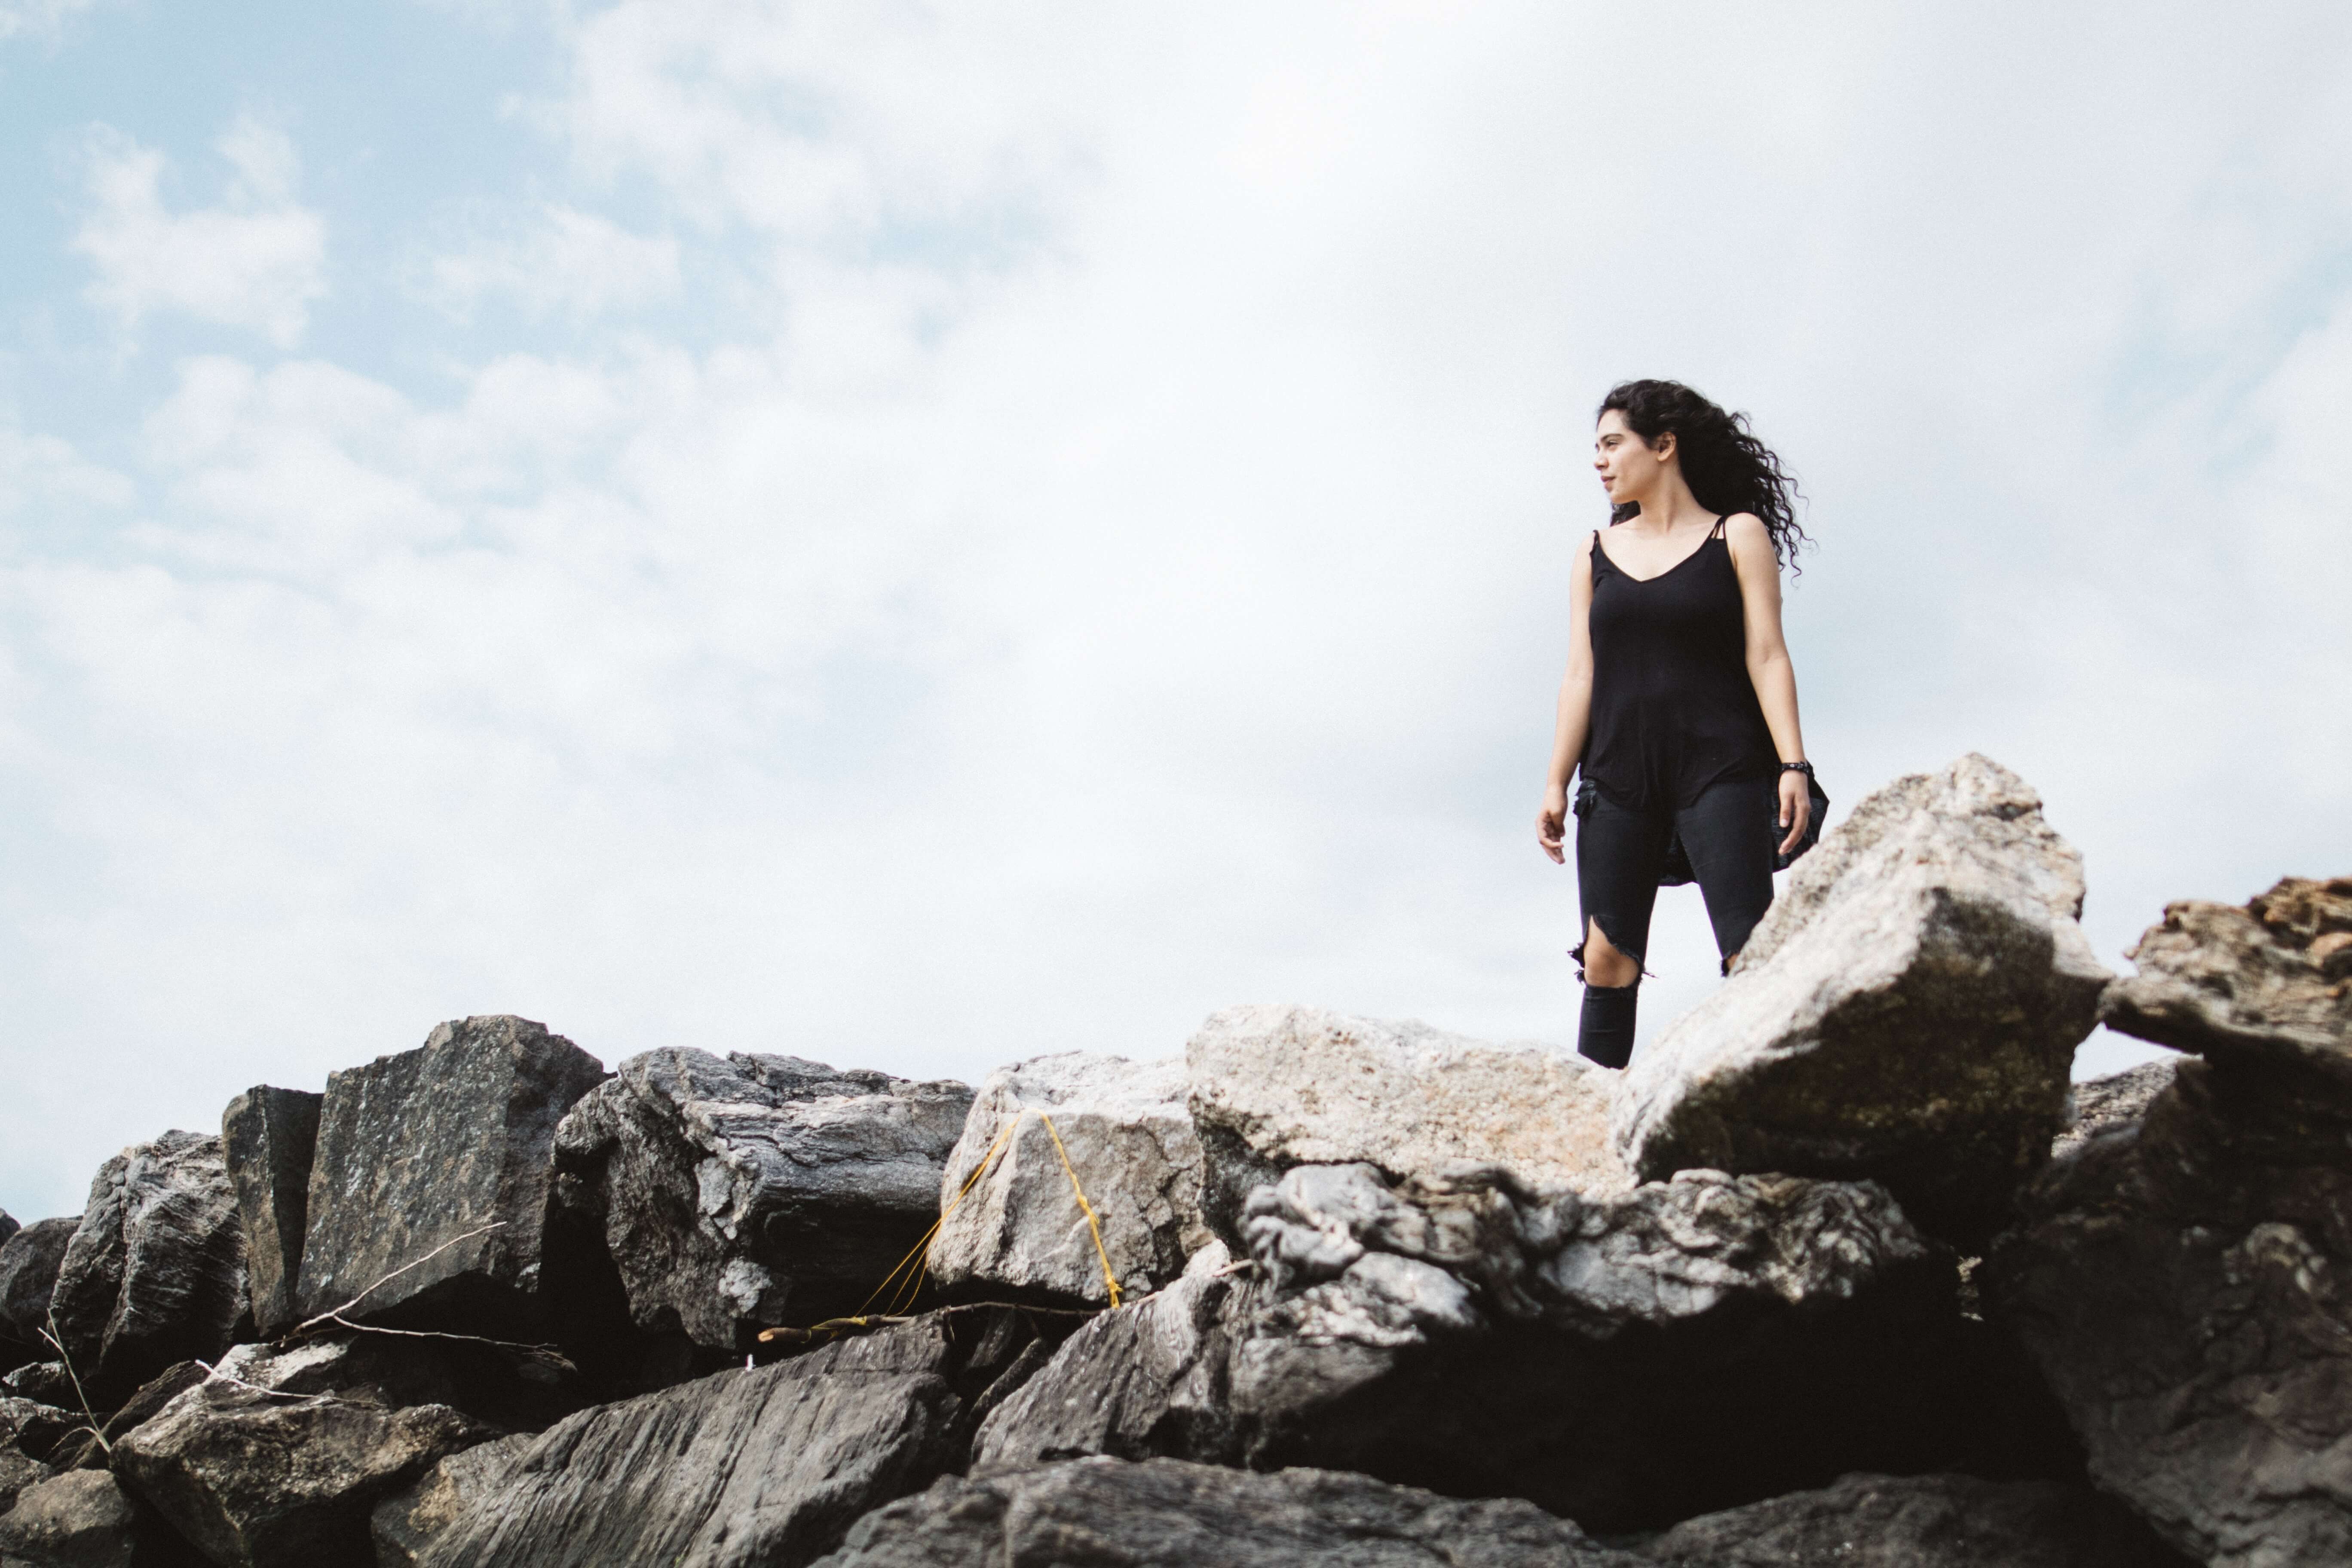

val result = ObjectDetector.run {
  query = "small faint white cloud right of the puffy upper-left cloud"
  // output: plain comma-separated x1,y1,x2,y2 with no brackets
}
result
426,202,677,320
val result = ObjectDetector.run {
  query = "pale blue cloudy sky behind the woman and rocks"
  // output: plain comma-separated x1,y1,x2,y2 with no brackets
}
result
0,0,2352,1220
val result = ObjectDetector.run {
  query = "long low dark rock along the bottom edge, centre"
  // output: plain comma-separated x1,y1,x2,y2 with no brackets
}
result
823,1460,1644,1568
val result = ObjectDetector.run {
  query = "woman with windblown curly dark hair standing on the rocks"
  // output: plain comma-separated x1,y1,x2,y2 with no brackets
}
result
1536,381,1813,1067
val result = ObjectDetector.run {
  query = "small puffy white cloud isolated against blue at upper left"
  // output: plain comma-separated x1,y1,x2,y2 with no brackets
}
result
73,115,327,348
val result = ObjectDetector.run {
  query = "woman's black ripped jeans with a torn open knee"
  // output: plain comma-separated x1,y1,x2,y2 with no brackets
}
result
1574,778,1780,1067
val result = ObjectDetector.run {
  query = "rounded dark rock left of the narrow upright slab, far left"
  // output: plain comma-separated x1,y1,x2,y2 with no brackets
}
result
49,1133,245,1408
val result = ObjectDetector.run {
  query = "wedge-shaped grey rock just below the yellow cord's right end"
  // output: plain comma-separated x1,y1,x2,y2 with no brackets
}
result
971,1243,1246,1472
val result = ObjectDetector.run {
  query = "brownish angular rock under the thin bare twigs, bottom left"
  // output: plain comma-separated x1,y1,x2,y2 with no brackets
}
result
113,1378,494,1568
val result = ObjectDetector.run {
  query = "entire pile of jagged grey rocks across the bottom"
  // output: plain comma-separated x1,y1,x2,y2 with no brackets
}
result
0,757,2352,1568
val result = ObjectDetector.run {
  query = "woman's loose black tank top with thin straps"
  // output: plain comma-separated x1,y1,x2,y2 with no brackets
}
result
1583,520,1780,808
